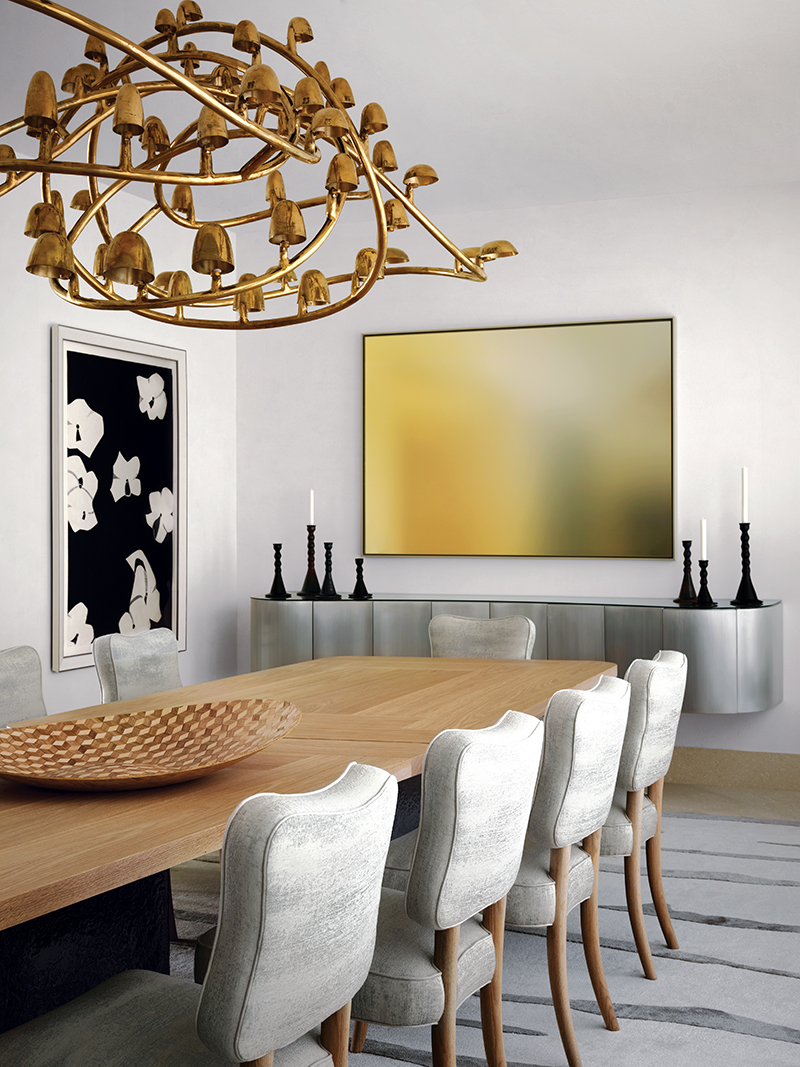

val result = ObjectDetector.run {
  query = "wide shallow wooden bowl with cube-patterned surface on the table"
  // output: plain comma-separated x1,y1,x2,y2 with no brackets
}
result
0,700,300,792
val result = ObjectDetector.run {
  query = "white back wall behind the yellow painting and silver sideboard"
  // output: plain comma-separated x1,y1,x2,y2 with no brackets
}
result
238,184,800,752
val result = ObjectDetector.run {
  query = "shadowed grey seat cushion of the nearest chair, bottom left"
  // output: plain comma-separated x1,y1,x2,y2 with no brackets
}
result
0,971,333,1067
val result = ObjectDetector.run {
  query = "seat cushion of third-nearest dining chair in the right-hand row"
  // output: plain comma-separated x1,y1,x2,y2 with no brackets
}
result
506,845,594,926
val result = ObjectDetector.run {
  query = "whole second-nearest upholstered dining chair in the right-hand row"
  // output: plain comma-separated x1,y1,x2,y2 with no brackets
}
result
352,712,543,1067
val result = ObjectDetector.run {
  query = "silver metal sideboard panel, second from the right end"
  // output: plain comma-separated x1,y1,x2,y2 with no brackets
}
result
663,608,740,715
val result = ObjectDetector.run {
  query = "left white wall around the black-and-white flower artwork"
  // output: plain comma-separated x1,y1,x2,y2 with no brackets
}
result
0,189,237,713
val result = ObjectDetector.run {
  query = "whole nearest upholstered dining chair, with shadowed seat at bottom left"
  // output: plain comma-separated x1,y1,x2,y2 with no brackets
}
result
0,764,397,1067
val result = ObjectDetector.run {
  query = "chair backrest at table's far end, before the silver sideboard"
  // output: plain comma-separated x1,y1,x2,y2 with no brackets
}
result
428,615,537,659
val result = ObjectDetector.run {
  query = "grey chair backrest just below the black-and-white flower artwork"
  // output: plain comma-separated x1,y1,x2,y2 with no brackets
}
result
92,627,183,704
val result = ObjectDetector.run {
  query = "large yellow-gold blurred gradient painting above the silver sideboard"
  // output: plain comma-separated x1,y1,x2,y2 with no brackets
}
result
364,319,673,559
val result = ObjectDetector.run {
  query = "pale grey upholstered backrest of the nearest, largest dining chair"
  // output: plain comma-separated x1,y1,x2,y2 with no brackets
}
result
197,763,397,1063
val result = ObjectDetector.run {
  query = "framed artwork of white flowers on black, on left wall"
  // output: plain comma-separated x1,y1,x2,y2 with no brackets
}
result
52,327,187,671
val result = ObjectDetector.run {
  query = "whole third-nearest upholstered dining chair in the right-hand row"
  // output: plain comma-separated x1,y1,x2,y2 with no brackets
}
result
506,676,630,1067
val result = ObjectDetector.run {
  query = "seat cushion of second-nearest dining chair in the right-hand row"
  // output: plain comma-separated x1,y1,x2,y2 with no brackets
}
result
352,889,495,1026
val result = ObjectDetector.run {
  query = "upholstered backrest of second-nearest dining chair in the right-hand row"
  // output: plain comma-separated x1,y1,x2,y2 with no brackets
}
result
405,712,543,929
